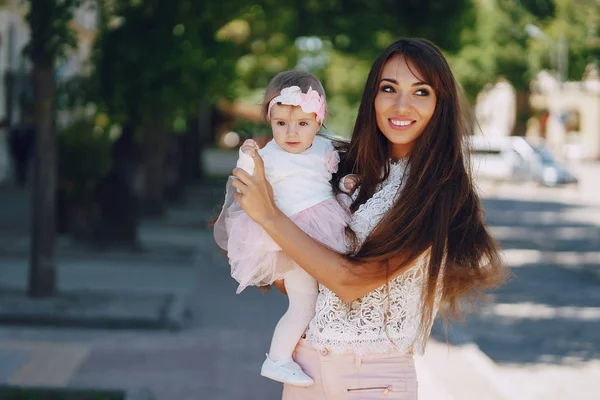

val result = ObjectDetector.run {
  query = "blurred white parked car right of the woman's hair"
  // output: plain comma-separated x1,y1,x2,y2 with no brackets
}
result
469,136,578,186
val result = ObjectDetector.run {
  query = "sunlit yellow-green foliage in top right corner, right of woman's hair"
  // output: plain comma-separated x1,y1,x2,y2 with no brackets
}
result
450,0,600,99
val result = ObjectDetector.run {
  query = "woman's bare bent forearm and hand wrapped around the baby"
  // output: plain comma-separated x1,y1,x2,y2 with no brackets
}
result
232,151,394,301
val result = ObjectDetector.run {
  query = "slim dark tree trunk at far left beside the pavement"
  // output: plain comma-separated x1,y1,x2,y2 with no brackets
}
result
29,62,56,297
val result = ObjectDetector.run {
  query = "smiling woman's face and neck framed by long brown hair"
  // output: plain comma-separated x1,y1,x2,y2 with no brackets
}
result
375,55,437,159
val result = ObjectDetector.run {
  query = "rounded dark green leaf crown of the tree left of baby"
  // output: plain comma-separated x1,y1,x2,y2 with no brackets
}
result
94,0,249,124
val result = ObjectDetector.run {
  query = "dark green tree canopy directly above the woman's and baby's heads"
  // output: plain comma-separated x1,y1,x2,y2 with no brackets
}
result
229,0,472,86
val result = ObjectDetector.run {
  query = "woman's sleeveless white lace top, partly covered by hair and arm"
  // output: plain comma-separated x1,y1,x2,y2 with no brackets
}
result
306,160,436,355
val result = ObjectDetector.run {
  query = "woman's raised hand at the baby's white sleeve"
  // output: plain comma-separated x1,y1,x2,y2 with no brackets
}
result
231,149,281,226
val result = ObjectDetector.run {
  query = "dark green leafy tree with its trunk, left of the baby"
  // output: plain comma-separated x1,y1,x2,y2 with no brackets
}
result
94,0,239,215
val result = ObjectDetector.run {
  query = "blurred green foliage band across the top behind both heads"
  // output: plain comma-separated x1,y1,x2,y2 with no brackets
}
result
52,0,600,142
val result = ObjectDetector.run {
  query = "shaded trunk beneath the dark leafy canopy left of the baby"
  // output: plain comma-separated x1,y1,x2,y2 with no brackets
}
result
140,116,169,216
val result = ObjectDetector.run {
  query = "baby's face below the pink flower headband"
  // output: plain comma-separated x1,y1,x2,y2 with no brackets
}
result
271,104,321,154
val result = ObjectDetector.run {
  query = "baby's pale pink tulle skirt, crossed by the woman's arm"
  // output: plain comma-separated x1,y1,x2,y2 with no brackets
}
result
215,192,349,293
